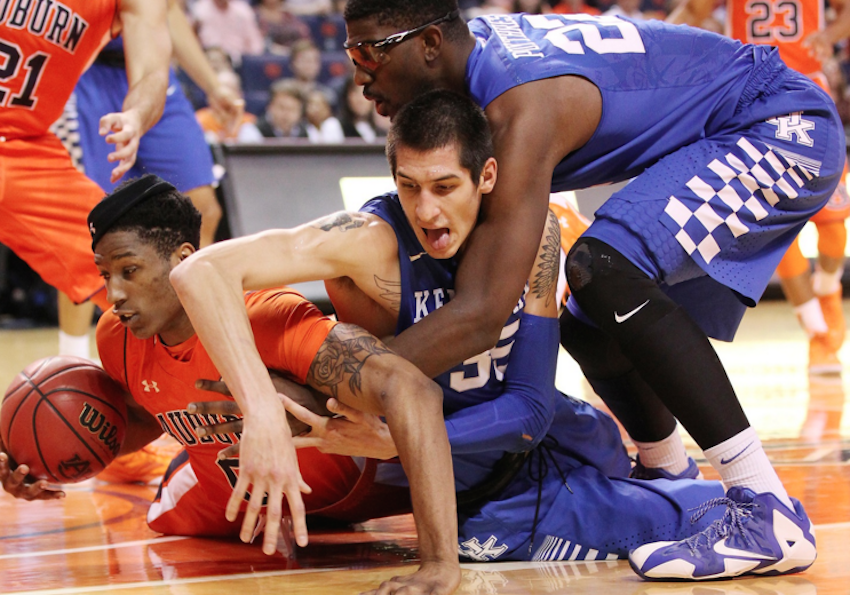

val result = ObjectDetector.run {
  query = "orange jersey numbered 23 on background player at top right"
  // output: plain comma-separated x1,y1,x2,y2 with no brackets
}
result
726,0,824,76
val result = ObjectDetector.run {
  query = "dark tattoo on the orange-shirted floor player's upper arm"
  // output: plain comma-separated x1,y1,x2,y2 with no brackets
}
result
307,324,392,397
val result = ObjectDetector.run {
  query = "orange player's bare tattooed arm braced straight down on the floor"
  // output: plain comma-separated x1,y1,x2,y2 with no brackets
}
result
307,324,460,594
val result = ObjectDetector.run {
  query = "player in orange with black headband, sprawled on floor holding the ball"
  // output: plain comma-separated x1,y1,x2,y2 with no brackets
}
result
2,175,460,593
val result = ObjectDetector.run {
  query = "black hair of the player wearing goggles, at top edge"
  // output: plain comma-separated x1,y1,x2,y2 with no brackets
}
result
343,0,469,41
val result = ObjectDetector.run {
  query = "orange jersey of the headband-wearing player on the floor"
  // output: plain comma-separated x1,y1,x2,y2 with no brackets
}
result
97,289,348,510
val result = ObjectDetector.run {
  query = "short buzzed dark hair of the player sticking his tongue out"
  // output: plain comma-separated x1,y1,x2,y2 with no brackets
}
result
387,90,494,185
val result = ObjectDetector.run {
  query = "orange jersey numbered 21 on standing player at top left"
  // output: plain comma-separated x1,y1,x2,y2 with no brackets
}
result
0,0,118,138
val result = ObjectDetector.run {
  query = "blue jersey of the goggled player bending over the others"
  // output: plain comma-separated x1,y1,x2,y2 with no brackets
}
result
466,14,784,192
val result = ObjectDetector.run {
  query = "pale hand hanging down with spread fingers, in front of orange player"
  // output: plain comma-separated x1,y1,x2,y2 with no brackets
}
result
232,402,311,555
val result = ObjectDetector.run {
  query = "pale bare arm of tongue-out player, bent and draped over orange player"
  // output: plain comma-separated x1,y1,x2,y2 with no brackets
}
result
171,217,398,554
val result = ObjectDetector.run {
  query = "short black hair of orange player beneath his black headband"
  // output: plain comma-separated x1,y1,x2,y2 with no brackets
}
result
106,180,201,258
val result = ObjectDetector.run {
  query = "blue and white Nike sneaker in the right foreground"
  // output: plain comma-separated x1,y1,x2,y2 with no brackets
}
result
629,487,817,581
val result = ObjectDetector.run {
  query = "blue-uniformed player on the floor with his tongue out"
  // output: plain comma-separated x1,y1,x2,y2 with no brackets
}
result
172,92,736,561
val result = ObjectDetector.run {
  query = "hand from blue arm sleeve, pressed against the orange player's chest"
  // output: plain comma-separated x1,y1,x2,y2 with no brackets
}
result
282,398,398,460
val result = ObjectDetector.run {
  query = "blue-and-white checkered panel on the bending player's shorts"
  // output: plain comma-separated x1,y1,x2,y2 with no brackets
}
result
664,137,816,263
